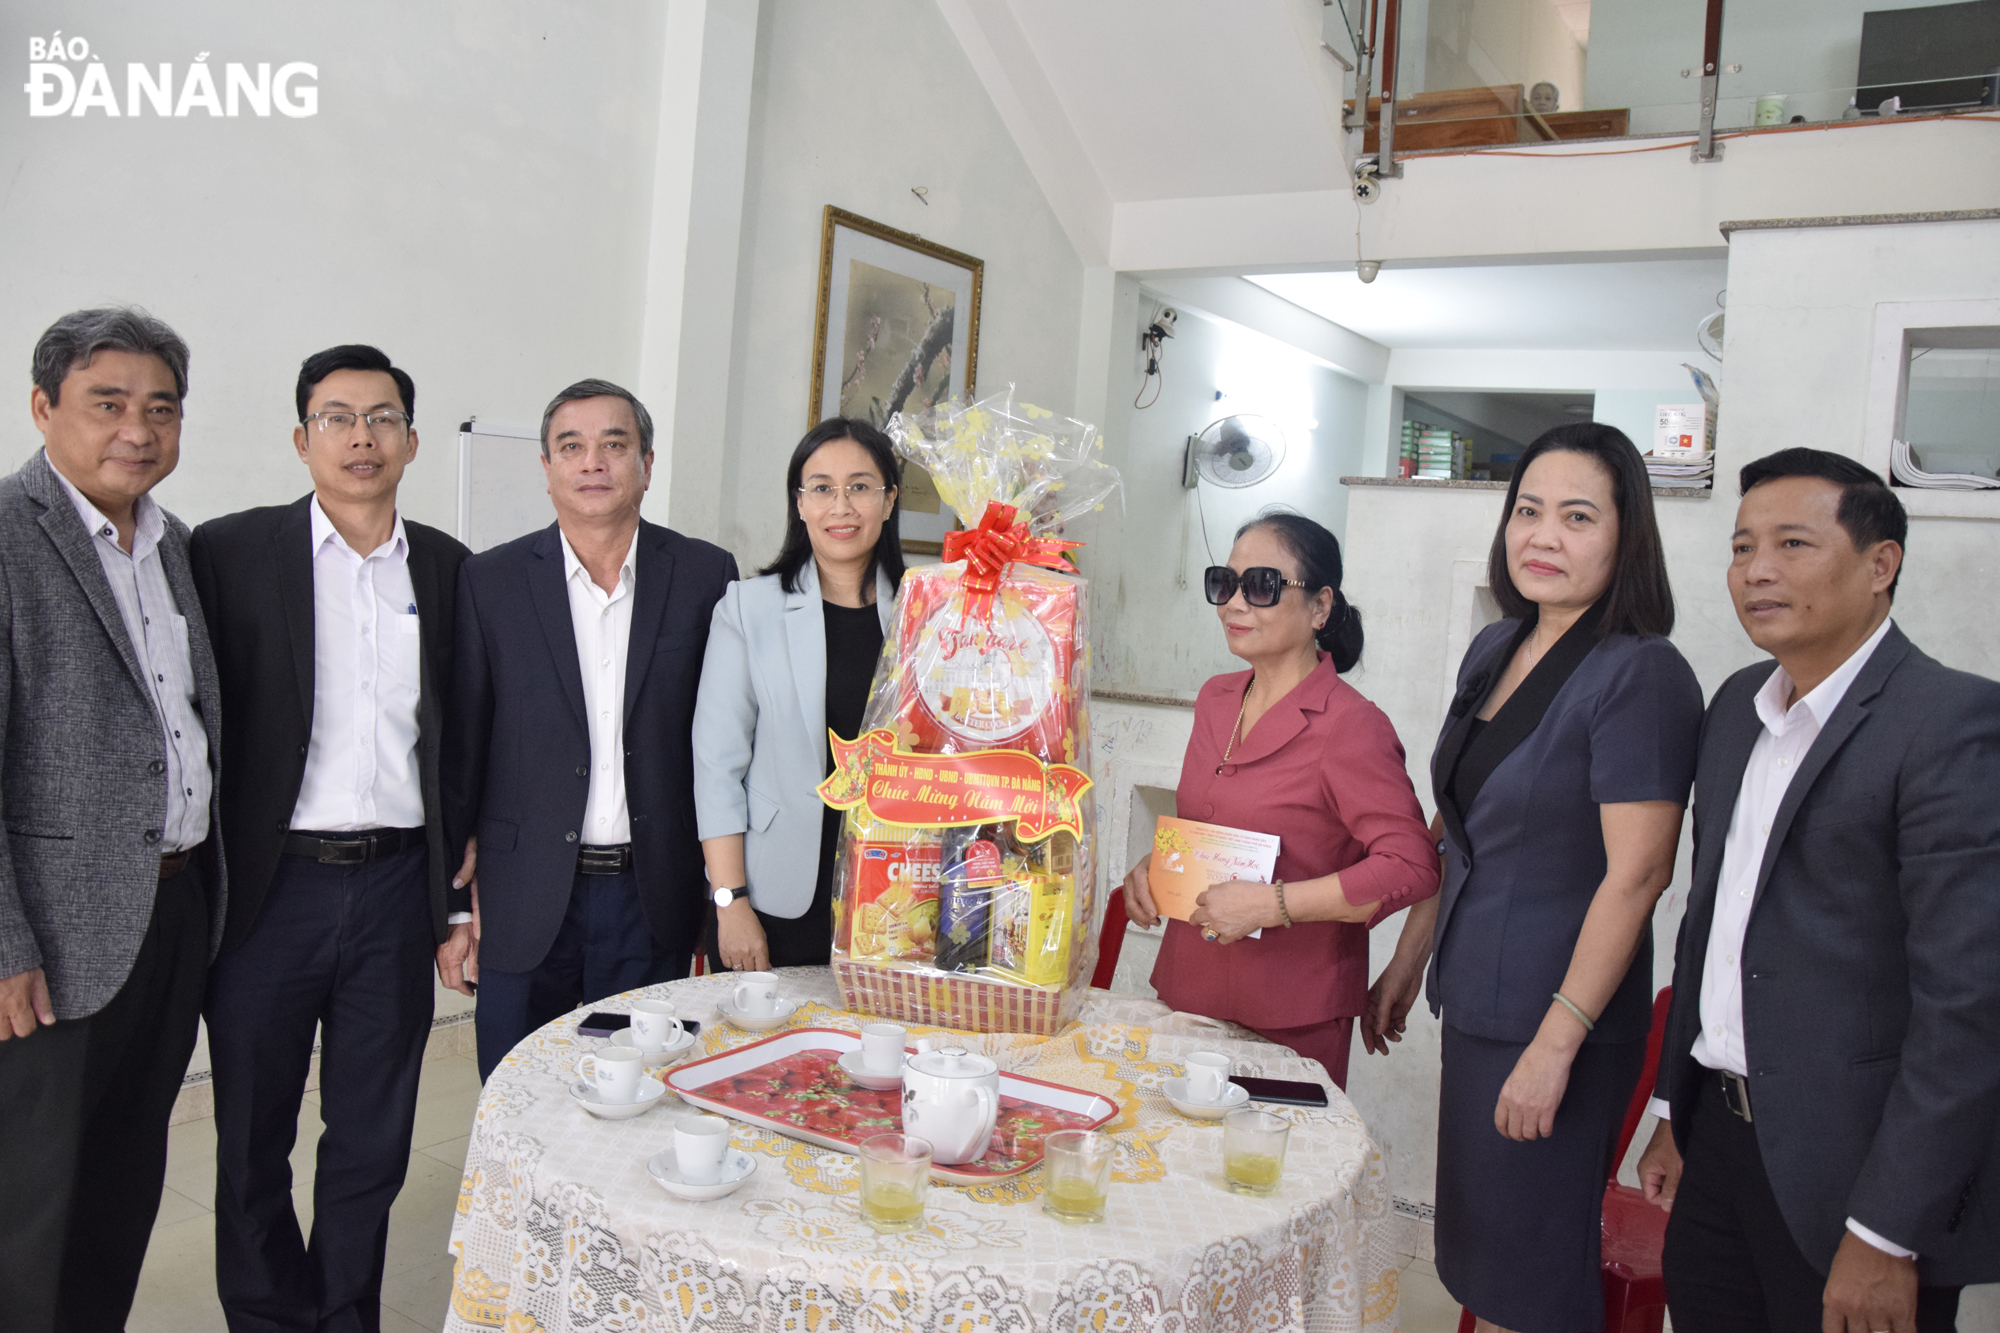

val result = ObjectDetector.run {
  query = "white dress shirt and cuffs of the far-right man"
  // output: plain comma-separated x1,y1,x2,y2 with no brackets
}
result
1650,618,1914,1259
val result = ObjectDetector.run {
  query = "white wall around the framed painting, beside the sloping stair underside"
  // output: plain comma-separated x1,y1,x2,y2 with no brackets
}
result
720,0,1102,570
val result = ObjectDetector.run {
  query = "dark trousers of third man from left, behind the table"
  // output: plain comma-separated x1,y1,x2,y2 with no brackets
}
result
472,869,694,1083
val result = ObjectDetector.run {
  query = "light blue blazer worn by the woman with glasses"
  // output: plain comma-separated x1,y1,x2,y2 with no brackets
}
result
694,560,896,919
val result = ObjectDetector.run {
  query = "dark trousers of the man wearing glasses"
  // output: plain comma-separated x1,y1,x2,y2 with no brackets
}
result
208,847,436,1333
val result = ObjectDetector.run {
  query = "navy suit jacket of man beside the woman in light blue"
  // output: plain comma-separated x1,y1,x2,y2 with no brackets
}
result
444,522,736,973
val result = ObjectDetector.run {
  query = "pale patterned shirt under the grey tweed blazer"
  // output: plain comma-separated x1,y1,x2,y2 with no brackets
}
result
50,466,212,855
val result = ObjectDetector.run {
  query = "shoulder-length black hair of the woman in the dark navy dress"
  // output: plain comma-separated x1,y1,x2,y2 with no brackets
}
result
1486,420,1674,638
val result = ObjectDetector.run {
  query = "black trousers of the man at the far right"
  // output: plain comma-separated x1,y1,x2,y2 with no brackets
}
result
1664,1075,1958,1333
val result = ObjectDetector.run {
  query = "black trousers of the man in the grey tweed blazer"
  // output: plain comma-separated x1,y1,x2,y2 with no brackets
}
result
0,861,208,1333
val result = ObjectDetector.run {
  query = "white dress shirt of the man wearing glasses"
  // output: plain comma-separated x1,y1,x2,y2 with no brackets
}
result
292,496,424,833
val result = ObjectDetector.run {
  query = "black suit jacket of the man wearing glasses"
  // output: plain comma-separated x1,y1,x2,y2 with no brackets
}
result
188,494,472,949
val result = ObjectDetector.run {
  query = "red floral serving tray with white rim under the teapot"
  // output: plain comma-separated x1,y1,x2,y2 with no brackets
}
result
666,1027,1118,1185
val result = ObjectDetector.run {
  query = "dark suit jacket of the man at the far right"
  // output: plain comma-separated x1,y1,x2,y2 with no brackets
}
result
1658,626,2000,1287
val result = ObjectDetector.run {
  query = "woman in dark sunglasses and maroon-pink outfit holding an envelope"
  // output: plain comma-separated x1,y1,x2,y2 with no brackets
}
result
1124,514,1438,1087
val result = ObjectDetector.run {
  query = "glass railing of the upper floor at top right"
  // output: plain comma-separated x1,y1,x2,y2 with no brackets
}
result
1326,0,2000,156
